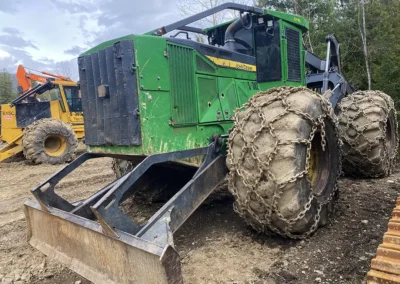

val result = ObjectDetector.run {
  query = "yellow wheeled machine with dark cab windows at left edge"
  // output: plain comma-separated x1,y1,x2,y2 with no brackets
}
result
0,65,84,164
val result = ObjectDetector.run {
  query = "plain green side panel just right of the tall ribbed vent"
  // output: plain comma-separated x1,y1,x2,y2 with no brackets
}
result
197,75,222,123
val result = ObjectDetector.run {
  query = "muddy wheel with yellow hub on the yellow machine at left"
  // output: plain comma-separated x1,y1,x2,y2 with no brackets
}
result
22,118,78,165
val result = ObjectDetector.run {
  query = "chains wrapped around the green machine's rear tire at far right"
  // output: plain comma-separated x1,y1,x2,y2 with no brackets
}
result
338,91,399,178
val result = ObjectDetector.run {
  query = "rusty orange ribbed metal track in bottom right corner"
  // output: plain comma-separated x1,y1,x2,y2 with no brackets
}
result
367,197,400,284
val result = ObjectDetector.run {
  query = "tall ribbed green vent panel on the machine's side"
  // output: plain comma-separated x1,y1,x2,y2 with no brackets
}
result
168,44,197,125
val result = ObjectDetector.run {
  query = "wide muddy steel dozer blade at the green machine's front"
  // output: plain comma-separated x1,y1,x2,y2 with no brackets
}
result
24,201,183,284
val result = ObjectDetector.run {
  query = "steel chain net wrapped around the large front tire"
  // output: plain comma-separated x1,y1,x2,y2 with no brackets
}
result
227,87,342,239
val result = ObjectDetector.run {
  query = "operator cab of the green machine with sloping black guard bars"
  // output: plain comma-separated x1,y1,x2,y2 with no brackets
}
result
152,3,309,85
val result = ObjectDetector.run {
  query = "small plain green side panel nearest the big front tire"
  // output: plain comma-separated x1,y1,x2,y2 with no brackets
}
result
218,78,239,120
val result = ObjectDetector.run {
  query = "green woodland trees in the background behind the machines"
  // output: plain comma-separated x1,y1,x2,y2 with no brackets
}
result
0,0,400,106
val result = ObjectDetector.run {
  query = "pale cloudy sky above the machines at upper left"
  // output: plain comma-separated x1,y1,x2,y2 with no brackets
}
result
0,0,180,73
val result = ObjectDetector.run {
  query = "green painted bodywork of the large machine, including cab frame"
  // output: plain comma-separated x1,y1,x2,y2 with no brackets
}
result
84,10,308,158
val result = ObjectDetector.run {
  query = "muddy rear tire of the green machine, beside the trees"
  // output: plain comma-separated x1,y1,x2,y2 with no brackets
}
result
338,91,398,177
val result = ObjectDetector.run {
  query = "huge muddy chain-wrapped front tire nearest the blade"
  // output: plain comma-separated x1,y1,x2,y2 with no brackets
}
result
227,87,341,239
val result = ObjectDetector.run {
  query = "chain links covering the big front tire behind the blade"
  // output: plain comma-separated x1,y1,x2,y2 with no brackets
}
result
227,87,341,239
